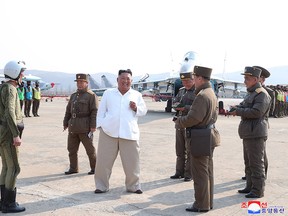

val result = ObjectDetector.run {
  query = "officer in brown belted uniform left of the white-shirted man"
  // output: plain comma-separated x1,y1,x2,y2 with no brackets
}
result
63,74,98,175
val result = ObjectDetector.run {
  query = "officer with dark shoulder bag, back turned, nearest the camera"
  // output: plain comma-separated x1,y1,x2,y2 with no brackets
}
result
175,66,220,212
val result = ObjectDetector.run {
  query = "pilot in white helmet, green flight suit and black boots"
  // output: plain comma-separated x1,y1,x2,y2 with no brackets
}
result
0,61,26,213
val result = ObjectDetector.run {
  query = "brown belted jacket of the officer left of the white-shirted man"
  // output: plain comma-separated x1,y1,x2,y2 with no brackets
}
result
63,90,98,133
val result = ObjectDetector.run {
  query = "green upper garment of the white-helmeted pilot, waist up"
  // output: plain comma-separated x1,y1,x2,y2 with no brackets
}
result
0,83,23,145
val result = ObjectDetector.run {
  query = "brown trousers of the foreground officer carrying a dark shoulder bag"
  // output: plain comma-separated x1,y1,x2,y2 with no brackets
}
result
191,148,214,210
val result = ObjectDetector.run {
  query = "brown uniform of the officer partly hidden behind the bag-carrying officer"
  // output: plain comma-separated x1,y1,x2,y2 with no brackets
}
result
173,86,195,179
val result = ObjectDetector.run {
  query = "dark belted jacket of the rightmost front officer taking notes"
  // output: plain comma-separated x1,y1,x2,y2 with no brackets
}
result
236,83,271,139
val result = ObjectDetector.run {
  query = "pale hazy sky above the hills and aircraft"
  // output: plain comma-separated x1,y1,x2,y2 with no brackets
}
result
0,0,288,75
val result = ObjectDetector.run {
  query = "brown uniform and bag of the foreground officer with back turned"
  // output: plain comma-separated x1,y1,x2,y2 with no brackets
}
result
176,82,220,211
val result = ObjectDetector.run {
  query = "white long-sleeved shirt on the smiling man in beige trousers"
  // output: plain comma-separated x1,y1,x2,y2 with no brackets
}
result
97,88,147,140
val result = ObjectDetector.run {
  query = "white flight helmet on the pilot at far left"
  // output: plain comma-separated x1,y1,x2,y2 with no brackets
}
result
4,61,26,80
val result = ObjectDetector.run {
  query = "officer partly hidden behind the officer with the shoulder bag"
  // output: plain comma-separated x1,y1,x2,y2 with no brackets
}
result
170,64,195,181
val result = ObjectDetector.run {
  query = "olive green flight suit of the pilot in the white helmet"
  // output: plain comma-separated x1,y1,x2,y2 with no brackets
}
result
0,83,23,190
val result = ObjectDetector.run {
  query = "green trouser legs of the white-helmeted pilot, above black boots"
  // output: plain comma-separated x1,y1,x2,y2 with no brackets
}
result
0,144,20,190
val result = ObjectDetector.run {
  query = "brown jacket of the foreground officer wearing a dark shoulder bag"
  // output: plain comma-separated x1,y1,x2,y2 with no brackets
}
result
176,82,220,147
